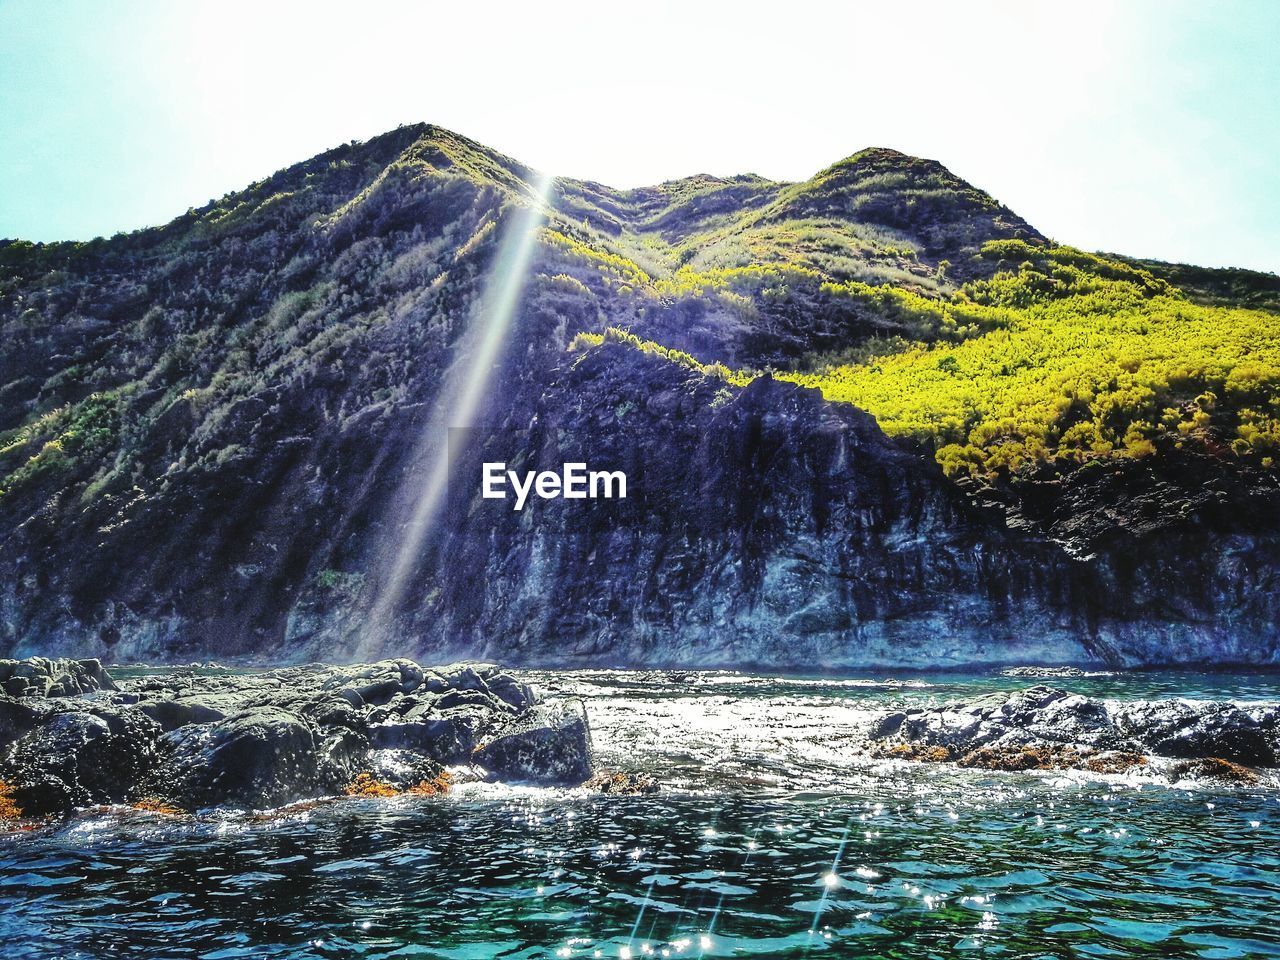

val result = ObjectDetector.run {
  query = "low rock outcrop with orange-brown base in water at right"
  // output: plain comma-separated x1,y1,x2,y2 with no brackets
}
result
869,686,1280,769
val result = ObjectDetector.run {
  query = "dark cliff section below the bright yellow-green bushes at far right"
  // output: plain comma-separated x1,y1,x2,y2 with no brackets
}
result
978,449,1280,666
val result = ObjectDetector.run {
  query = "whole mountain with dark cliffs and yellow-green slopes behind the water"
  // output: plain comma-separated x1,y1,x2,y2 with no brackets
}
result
0,125,1280,669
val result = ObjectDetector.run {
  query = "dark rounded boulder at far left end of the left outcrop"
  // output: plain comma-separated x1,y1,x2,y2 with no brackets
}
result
0,707,161,815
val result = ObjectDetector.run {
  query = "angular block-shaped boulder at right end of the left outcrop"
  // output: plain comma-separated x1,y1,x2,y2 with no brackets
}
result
474,700,591,786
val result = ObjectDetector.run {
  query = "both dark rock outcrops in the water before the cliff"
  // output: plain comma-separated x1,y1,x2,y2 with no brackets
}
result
0,658,1280,820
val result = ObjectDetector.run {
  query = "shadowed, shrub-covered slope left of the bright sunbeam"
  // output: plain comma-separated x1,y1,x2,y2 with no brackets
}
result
0,128,525,509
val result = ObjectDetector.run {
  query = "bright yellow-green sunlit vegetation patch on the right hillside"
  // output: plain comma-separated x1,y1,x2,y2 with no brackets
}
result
785,241,1280,474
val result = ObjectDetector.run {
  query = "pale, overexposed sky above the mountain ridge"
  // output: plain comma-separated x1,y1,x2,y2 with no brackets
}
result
0,0,1280,271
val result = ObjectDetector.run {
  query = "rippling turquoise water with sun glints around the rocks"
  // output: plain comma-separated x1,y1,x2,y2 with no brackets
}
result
0,672,1280,960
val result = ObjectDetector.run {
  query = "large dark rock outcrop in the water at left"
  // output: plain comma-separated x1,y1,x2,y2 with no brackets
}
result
0,659,591,815
